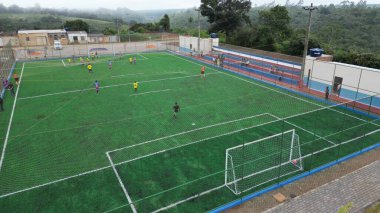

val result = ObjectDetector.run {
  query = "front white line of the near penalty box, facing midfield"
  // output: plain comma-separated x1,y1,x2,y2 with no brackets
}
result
108,113,270,153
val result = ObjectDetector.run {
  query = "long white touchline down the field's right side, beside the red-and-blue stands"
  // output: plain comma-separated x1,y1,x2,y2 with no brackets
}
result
167,53,380,126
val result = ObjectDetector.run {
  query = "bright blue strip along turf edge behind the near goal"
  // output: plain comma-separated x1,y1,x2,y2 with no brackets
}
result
209,142,380,213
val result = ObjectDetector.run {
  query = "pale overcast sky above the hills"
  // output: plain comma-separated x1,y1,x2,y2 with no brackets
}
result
0,0,380,10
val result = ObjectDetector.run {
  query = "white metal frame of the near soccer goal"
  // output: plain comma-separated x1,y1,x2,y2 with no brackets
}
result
224,129,303,195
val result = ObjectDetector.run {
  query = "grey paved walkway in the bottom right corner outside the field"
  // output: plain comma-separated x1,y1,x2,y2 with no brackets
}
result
265,161,380,213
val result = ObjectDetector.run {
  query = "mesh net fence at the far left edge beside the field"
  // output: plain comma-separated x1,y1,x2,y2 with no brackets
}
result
0,42,16,96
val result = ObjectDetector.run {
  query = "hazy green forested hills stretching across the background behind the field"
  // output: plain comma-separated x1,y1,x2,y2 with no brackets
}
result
0,0,380,68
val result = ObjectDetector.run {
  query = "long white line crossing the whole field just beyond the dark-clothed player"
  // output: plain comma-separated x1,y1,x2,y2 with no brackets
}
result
19,73,218,100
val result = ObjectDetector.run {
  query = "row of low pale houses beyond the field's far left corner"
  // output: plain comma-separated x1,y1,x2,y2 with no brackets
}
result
0,29,118,47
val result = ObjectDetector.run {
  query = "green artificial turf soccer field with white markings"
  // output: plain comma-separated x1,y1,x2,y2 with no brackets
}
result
0,52,380,212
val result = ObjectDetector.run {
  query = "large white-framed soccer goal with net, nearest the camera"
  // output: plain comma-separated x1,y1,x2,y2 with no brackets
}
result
225,129,303,195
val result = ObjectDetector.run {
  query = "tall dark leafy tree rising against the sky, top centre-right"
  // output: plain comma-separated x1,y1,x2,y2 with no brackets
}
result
200,0,251,38
